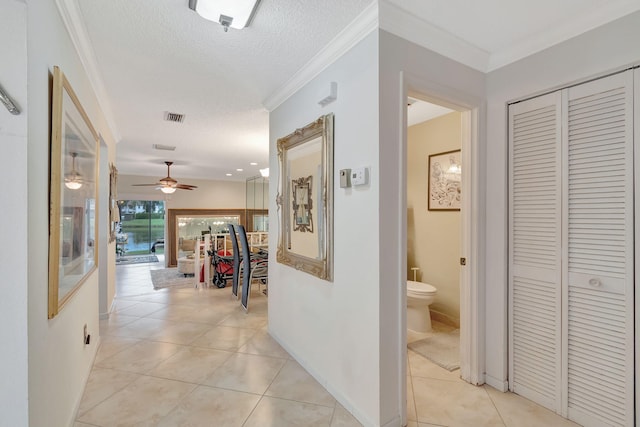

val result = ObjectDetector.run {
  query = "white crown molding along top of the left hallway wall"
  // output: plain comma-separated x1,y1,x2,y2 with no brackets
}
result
56,0,121,144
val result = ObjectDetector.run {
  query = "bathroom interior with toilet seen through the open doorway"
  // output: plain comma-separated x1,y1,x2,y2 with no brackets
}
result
406,97,463,356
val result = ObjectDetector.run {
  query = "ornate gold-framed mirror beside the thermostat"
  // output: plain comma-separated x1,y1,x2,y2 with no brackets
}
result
276,114,333,281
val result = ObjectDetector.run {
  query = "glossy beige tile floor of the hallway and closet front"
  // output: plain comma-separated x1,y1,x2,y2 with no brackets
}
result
74,263,576,427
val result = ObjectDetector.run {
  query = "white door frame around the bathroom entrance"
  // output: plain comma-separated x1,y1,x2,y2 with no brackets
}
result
400,83,484,424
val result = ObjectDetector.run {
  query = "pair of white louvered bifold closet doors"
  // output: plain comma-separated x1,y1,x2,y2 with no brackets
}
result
509,72,635,426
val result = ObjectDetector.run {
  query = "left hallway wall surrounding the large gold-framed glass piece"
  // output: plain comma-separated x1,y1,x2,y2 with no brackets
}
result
26,0,115,426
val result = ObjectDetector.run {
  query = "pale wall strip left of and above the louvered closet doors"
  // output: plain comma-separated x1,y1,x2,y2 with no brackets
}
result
485,12,640,388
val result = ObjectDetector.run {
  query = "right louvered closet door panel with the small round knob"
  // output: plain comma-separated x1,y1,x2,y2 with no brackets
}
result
563,72,634,426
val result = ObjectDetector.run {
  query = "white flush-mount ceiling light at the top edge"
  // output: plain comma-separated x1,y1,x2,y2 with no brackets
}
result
189,0,260,32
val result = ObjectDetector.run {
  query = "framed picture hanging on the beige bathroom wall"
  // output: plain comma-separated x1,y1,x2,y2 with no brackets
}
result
427,150,462,211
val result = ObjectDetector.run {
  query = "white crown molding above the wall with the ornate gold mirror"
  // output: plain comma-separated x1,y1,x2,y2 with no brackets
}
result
262,2,378,111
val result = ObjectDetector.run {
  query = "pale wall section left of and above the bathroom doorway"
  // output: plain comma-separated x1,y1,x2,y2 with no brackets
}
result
378,29,485,424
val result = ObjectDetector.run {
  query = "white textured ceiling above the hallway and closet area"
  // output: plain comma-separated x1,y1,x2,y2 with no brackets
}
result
76,0,640,185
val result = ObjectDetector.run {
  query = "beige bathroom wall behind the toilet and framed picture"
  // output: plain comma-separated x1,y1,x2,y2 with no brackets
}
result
406,111,465,326
